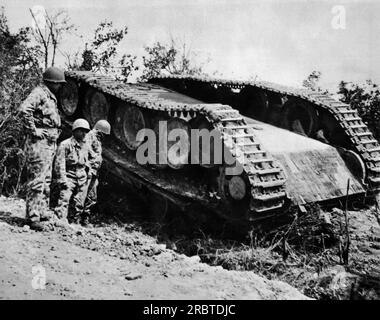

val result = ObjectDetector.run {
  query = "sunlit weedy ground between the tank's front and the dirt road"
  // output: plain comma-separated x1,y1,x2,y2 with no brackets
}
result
176,207,380,300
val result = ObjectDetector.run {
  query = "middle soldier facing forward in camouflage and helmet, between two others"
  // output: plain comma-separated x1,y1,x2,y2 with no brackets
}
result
54,119,90,225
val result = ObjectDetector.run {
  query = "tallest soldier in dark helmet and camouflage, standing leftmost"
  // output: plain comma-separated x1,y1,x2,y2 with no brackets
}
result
19,67,66,230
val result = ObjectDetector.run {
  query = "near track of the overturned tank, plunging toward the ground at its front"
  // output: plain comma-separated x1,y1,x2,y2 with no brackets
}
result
65,71,287,218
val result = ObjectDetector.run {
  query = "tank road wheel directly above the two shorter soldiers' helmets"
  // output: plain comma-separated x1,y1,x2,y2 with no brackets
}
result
83,89,110,126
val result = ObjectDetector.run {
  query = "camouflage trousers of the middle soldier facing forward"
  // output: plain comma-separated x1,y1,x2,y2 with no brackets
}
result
54,173,88,219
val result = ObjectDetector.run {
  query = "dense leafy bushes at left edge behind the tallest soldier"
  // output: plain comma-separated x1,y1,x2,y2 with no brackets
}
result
0,8,41,194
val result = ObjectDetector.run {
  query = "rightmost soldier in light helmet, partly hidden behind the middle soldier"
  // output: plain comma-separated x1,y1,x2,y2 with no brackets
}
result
82,120,111,225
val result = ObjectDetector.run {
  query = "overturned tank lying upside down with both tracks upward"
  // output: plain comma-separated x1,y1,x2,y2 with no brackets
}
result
59,71,380,225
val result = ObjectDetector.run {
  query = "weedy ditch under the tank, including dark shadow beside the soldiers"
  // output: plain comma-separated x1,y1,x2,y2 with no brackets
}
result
94,181,380,300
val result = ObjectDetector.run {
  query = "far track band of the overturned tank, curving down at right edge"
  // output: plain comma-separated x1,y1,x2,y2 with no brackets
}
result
150,75,380,190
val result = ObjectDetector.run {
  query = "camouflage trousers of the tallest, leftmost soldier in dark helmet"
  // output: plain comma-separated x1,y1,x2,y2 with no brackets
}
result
25,136,57,221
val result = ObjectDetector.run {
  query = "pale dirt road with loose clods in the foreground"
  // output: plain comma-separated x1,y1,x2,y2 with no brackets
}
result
0,197,306,299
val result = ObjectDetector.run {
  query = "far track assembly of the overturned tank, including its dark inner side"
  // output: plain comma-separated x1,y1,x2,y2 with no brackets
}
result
149,76,380,192
